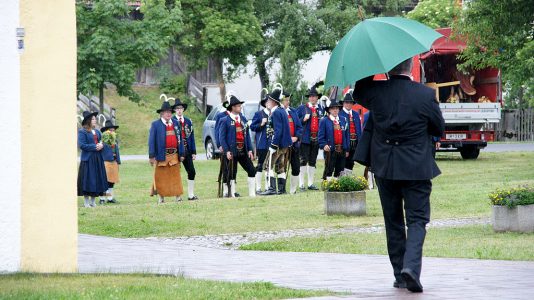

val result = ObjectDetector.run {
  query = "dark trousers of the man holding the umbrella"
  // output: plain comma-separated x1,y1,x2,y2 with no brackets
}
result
375,177,432,280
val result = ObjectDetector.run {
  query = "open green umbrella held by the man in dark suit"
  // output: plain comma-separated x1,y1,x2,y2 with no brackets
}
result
325,17,441,88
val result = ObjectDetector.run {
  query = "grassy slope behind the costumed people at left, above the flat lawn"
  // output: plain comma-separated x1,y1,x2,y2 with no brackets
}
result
104,87,206,155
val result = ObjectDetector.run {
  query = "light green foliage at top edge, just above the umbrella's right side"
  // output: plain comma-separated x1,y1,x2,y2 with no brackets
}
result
406,0,462,28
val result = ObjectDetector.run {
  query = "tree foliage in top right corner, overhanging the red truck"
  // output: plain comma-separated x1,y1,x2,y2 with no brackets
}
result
454,0,534,107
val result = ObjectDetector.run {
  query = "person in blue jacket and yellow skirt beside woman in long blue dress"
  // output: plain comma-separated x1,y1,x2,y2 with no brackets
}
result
100,120,121,204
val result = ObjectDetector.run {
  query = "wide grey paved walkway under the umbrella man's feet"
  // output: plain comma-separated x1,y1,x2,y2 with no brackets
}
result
78,234,534,299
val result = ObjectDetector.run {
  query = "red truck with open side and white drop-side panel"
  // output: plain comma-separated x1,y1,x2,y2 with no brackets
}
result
355,28,503,159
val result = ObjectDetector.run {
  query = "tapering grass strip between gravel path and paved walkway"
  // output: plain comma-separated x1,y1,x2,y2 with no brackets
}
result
240,225,534,260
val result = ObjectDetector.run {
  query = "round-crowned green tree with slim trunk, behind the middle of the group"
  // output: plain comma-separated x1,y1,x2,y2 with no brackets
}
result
177,0,263,101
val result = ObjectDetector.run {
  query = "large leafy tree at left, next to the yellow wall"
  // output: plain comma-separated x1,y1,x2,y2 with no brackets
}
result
76,0,181,111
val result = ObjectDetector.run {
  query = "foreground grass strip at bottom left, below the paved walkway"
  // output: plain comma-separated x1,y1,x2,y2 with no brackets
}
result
0,274,334,299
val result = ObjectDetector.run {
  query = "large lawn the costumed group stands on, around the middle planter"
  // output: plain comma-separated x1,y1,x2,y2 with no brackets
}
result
78,152,534,237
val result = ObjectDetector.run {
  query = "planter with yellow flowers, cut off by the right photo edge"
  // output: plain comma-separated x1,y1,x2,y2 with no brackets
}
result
489,186,534,232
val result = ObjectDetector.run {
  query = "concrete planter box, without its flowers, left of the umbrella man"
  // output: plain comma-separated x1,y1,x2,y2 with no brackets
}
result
324,191,367,216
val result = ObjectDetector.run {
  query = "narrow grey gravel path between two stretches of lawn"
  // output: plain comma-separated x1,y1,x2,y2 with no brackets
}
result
143,218,491,250
